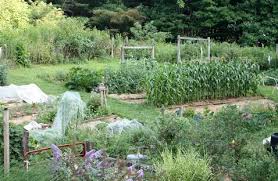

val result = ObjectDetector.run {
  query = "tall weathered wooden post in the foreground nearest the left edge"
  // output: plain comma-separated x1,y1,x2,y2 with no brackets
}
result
3,108,10,174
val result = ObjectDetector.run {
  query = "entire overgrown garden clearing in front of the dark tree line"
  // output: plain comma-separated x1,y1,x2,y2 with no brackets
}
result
0,0,278,181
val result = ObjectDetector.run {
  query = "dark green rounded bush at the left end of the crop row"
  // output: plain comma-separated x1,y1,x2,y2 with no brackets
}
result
66,67,102,92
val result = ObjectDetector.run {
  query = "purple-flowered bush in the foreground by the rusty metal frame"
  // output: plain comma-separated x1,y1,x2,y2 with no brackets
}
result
51,144,144,181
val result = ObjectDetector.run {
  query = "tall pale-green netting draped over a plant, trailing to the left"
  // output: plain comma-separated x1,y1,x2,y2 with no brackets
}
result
30,91,86,144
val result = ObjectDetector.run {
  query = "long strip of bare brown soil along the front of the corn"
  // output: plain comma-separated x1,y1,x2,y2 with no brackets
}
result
167,97,275,113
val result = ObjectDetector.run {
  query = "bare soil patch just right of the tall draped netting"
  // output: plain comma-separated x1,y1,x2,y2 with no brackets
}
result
79,115,122,129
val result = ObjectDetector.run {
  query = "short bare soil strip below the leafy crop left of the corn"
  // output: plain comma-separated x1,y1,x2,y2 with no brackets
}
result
109,93,146,104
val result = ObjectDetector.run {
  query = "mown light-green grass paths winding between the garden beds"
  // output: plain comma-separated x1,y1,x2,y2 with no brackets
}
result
8,60,159,121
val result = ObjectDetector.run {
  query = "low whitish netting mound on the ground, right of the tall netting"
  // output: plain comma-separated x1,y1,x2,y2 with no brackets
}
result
107,119,143,134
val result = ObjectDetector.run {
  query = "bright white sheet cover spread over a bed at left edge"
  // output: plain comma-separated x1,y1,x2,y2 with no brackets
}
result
0,84,48,104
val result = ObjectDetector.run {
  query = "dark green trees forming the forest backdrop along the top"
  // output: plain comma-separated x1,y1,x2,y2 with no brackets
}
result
47,0,278,45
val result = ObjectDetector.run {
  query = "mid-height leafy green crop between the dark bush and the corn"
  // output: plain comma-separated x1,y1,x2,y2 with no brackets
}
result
105,63,146,94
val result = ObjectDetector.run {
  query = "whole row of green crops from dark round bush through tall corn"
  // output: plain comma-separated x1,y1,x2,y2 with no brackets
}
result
40,61,260,106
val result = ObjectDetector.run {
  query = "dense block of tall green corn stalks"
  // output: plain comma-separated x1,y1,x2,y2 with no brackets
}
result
146,61,258,105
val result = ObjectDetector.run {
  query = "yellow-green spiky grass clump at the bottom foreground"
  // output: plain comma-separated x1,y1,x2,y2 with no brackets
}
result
155,149,212,181
